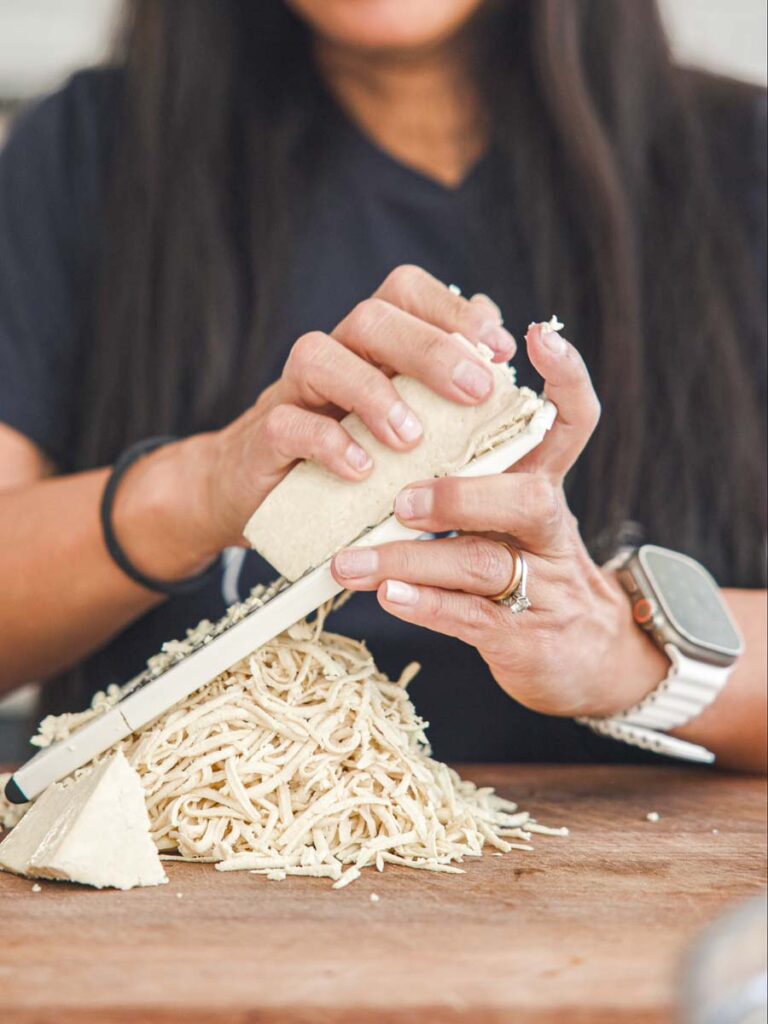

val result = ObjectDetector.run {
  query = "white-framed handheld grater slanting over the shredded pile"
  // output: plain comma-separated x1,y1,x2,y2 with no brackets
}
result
5,401,556,804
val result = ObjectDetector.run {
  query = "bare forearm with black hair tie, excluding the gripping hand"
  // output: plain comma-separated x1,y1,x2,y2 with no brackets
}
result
0,439,215,690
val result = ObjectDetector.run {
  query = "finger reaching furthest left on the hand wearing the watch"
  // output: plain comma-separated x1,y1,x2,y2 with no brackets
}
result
331,535,515,597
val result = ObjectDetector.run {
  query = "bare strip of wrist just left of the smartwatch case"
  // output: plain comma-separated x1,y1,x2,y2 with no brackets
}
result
582,569,670,718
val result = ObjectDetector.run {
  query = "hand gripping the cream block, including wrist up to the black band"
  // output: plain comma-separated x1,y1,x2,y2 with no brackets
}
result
113,265,515,580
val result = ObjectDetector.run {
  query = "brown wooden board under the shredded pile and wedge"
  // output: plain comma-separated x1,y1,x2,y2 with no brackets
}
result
0,766,766,1024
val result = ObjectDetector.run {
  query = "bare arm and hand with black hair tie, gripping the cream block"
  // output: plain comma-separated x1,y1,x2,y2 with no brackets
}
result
0,266,514,689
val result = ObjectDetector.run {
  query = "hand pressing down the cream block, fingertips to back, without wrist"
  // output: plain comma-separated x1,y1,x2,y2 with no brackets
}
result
186,265,515,551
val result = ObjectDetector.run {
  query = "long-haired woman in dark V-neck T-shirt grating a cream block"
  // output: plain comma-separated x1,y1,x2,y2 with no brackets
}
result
0,0,766,769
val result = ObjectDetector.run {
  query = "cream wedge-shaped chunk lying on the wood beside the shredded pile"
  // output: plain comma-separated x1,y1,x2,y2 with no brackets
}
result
0,751,168,889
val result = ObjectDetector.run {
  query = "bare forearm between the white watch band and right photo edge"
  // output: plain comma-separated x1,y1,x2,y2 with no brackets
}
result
674,590,768,772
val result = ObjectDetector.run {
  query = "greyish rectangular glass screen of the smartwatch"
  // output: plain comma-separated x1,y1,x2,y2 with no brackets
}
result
639,545,741,657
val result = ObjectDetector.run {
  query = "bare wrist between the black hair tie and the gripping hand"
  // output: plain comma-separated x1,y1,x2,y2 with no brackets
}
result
113,434,226,582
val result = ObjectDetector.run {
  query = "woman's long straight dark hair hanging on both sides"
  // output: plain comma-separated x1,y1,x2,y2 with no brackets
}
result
76,0,765,584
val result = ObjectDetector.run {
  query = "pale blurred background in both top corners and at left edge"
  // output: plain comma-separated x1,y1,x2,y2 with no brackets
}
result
0,0,768,760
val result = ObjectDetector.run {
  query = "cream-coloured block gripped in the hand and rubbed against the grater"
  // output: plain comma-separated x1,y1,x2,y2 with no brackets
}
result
244,348,543,582
